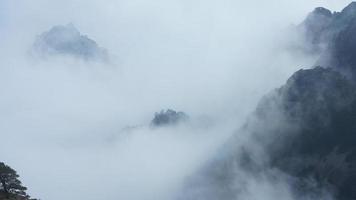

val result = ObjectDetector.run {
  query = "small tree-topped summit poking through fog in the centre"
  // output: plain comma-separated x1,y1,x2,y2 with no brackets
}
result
151,109,189,127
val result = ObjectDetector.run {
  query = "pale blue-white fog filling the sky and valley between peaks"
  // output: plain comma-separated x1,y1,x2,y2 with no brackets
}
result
0,0,349,200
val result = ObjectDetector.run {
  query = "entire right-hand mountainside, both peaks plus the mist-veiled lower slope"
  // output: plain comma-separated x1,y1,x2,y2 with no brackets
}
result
181,2,356,200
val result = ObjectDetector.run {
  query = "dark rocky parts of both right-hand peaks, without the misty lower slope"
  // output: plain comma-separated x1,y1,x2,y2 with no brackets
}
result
256,2,356,196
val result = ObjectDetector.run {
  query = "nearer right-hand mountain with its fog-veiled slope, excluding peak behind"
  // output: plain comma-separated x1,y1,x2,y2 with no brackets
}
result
181,67,356,200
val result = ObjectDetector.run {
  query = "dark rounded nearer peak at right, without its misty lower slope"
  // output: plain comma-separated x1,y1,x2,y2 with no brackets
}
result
247,68,356,200
